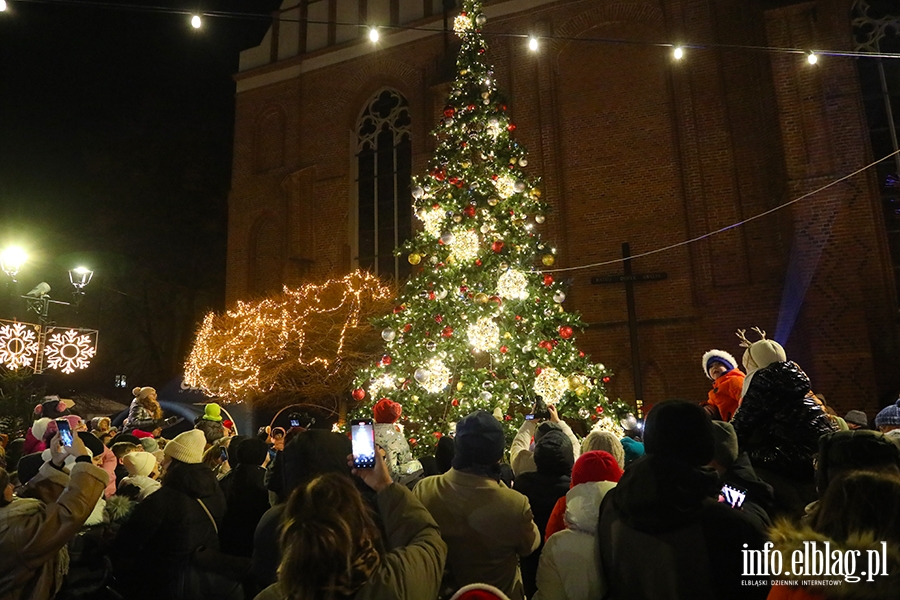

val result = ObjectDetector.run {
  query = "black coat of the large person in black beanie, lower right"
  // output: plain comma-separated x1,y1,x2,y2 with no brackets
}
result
597,455,769,600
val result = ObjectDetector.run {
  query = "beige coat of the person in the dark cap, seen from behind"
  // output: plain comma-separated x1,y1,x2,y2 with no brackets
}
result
414,469,540,600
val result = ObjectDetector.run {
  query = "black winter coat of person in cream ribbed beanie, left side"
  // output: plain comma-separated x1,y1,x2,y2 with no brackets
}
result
113,463,225,600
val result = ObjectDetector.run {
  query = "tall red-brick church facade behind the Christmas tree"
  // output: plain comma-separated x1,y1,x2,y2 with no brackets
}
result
227,0,900,417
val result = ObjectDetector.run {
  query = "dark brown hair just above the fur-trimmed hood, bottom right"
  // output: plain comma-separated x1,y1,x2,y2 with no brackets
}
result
812,471,900,545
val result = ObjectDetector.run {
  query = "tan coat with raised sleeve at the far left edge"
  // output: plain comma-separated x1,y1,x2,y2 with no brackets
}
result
0,463,109,600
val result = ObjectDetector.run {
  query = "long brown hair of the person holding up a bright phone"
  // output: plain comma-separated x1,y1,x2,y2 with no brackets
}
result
278,474,381,600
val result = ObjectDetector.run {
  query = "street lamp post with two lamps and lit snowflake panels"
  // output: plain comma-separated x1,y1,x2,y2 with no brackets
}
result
0,247,97,374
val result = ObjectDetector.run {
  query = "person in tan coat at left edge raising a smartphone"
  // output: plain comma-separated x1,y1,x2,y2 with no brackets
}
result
0,434,109,600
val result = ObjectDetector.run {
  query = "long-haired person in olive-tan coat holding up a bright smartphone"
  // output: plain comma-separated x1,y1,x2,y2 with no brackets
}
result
256,436,447,600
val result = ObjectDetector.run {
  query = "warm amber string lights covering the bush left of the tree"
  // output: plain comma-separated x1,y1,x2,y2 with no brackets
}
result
184,271,394,404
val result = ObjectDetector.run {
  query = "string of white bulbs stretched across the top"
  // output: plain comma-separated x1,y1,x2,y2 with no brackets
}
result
7,0,900,61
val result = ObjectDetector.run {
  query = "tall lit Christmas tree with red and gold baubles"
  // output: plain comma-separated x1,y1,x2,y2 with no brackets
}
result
351,0,629,453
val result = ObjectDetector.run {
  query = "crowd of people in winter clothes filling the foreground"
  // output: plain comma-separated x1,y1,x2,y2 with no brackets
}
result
0,330,900,600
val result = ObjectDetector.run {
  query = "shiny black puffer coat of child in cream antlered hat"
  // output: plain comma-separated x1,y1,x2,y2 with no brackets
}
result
731,361,835,482
